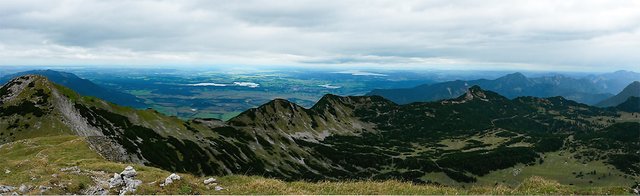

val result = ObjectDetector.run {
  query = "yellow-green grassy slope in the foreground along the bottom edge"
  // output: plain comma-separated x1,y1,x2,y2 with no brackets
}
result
0,136,627,194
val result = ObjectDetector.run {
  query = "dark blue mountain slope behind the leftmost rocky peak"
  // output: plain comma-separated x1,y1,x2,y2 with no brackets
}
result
0,70,147,108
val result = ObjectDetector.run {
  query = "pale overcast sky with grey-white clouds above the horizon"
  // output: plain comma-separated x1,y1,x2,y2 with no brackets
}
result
0,0,640,71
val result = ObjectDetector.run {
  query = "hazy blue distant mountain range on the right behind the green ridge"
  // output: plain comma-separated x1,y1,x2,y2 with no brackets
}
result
367,71,640,105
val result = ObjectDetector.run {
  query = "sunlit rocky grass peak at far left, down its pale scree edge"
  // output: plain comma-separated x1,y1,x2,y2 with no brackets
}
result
0,75,141,162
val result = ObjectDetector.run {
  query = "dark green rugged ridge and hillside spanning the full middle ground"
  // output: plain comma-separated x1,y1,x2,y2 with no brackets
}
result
0,75,640,193
